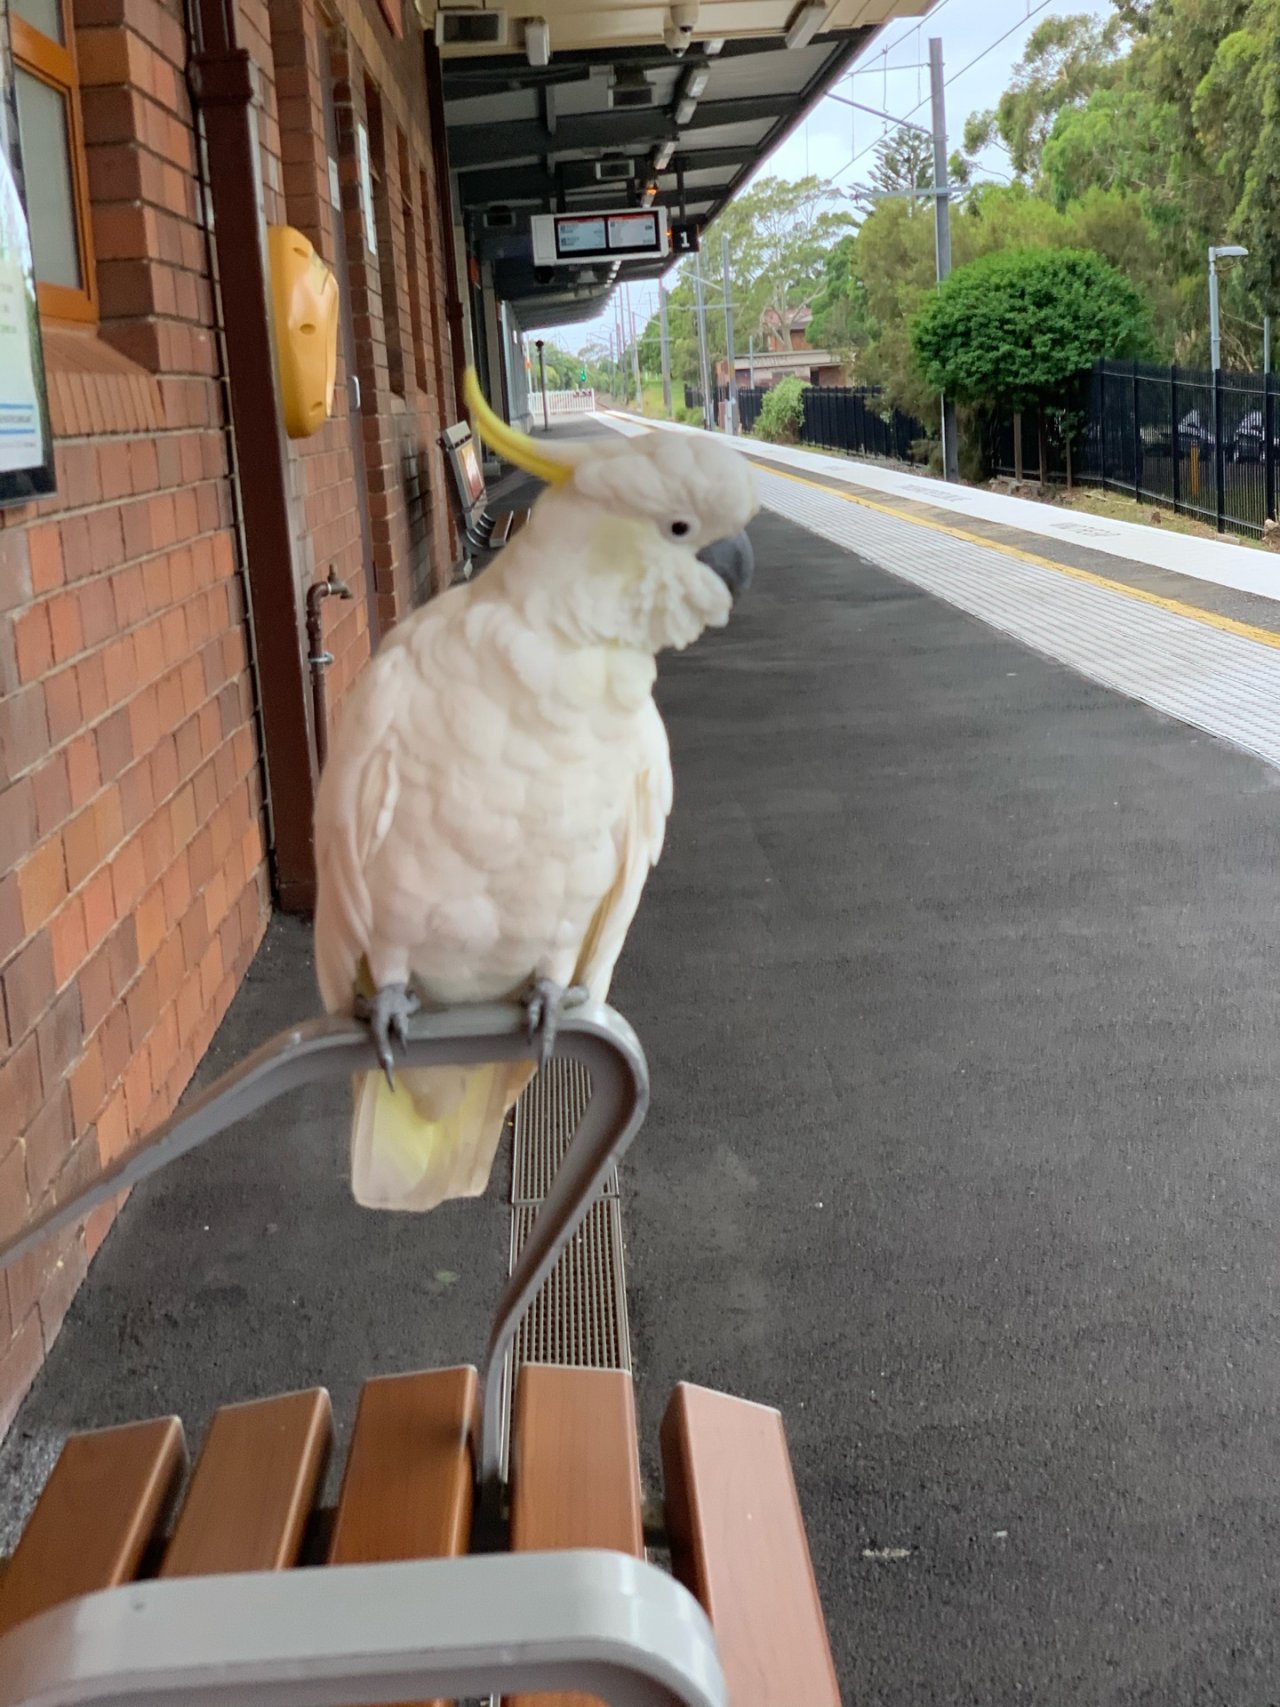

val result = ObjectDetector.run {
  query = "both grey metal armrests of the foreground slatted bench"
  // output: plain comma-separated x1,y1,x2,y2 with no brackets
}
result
0,1004,727,1707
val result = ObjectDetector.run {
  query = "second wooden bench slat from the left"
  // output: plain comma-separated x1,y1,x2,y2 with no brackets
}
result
160,1388,333,1577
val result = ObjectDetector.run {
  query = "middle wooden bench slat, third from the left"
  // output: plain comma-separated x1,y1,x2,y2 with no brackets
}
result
329,1369,478,1565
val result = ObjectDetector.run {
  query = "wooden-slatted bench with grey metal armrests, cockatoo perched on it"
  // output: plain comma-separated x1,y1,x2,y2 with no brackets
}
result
0,1007,840,1707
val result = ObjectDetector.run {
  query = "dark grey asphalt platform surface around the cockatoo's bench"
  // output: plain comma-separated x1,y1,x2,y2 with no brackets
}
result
0,498,1280,1707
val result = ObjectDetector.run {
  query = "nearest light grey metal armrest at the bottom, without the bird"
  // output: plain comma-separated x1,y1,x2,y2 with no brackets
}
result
0,1552,727,1707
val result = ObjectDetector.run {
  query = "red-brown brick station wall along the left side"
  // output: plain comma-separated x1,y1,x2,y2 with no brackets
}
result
0,0,454,1432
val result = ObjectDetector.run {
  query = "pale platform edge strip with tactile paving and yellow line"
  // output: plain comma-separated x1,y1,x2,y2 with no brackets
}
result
604,415,1280,781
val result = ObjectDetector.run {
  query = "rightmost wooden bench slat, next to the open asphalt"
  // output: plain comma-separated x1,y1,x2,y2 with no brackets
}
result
662,1384,840,1707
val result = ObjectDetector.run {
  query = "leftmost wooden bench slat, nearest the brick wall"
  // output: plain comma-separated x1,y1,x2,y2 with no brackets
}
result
0,1417,186,1635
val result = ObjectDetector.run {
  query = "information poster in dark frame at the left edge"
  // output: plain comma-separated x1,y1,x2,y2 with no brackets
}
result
0,0,55,504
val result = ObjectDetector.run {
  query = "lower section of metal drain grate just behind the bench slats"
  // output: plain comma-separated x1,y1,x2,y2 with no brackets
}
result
510,1197,631,1374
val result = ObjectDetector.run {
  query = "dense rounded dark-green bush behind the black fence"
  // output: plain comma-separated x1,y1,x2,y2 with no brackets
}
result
911,249,1154,410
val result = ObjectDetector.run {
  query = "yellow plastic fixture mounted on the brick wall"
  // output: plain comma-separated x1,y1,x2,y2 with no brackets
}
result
266,225,338,439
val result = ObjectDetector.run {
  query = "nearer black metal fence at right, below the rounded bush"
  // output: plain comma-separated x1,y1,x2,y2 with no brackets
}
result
988,362,1280,534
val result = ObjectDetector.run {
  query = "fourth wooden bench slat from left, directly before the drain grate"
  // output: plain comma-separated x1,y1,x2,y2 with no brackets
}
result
507,1364,645,1707
